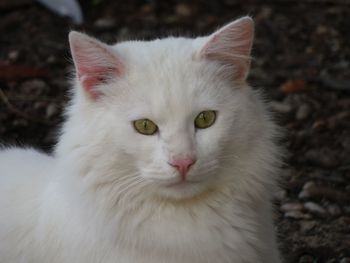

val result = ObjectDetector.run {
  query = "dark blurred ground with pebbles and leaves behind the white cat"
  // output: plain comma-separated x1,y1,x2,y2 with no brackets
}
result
0,0,350,263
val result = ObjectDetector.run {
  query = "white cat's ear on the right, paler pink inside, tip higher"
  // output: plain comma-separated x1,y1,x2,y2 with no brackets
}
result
200,16,254,80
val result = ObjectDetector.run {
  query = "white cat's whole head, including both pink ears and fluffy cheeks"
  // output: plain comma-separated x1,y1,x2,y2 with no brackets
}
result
61,17,276,203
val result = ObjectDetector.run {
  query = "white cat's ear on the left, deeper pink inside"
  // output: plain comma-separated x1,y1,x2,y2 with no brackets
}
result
69,31,124,99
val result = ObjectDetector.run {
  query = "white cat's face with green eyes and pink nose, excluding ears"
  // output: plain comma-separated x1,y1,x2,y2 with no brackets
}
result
103,42,236,200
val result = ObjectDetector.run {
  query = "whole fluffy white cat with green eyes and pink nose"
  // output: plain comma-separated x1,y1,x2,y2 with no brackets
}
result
0,17,281,263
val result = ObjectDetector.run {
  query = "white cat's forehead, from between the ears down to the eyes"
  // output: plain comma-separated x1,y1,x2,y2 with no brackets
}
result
107,38,232,121
